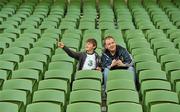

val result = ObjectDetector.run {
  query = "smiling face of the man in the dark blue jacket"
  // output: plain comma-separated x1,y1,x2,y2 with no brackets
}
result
105,38,116,52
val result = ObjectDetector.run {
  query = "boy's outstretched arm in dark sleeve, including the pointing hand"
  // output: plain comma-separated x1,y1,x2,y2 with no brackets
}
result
58,42,81,60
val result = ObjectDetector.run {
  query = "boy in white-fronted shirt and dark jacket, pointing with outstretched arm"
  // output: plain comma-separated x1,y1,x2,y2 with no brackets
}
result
58,39,101,71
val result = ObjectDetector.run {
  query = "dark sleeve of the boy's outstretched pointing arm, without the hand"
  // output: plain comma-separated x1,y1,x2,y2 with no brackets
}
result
63,46,81,60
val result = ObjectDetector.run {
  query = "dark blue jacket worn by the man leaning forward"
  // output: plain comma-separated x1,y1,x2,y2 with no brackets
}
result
101,45,132,69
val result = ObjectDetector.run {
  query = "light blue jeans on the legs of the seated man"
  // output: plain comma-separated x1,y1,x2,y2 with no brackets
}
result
103,66,136,92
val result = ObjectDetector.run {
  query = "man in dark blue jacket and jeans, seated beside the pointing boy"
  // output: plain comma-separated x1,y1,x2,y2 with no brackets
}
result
101,36,134,91
